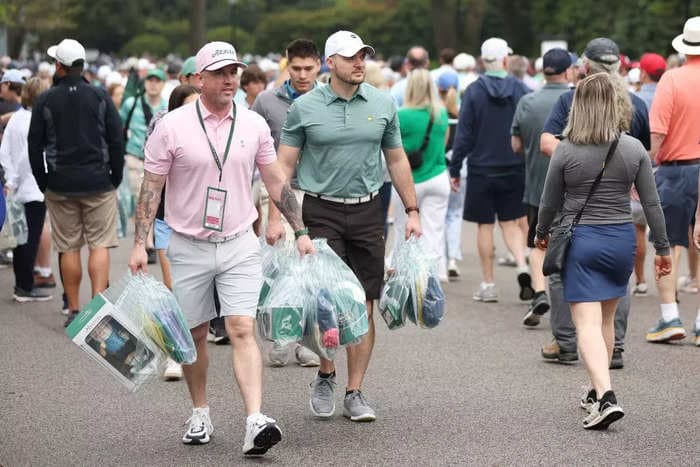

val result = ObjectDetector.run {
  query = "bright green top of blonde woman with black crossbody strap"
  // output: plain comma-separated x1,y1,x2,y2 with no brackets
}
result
399,107,448,183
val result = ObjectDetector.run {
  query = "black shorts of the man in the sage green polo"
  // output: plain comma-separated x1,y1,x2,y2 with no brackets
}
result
302,196,384,300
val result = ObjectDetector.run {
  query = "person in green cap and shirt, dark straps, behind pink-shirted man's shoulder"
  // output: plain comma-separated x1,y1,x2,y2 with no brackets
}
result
119,68,168,264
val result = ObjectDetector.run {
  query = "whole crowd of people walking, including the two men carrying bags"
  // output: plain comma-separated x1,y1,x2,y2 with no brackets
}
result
0,17,700,455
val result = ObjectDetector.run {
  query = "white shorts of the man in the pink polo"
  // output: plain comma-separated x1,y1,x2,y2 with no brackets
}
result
168,229,262,329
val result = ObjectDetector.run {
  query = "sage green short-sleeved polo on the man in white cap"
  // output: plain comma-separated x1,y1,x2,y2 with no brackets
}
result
280,83,401,198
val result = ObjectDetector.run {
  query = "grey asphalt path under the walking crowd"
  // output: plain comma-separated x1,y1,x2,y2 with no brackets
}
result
0,227,700,467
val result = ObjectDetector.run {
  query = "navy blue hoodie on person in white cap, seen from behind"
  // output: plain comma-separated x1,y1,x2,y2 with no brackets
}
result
450,75,530,178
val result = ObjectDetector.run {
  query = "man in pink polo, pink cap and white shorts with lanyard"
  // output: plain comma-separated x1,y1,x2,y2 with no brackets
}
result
129,42,314,455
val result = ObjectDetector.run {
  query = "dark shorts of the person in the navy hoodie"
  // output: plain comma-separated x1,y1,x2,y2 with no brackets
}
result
464,169,525,224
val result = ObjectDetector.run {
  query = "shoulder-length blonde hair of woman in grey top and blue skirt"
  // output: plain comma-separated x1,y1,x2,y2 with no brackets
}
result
563,73,629,144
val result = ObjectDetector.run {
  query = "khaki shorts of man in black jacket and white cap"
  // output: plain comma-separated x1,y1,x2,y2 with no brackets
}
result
45,190,119,253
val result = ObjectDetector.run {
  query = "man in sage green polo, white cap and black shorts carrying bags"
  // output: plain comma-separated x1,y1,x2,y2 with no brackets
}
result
268,31,421,422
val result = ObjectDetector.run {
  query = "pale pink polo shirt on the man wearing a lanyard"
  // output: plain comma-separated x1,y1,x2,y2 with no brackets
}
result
144,98,277,239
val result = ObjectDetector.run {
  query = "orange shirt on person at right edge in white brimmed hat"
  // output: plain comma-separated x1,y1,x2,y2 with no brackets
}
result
649,55,700,163
